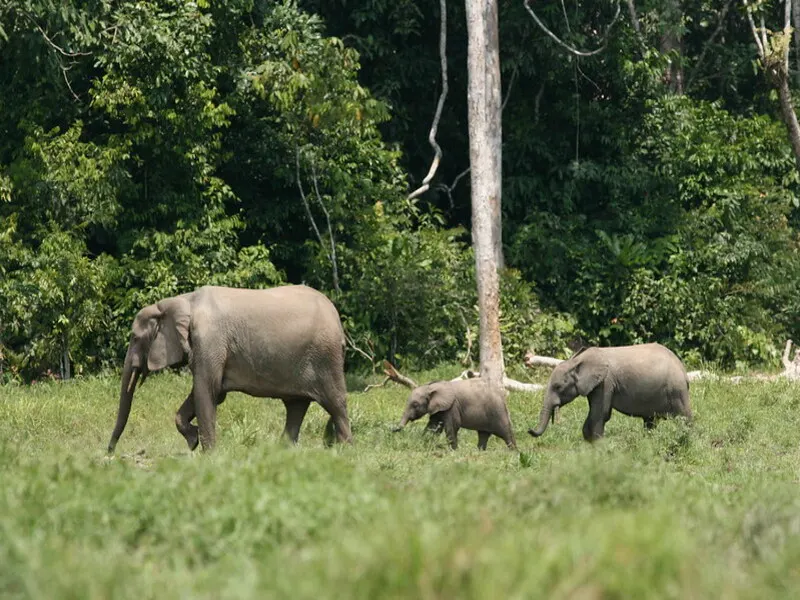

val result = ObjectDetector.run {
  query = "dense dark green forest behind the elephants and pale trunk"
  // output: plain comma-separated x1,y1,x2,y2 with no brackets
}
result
0,0,800,381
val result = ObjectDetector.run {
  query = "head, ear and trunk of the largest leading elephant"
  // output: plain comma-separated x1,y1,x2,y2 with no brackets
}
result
108,296,191,454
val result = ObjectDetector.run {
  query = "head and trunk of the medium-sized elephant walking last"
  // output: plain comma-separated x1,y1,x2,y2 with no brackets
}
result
528,348,608,437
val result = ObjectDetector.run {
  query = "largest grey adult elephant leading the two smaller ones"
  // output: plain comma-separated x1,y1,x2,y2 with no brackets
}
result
108,285,352,453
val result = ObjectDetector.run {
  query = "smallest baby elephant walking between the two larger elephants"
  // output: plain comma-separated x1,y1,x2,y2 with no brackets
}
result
394,379,517,450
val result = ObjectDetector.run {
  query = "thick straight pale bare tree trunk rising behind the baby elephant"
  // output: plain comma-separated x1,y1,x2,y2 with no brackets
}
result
465,0,505,386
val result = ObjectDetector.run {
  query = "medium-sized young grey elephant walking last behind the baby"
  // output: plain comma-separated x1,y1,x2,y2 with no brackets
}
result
528,344,692,442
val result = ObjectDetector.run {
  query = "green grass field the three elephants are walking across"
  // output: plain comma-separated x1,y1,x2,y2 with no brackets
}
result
0,368,800,599
